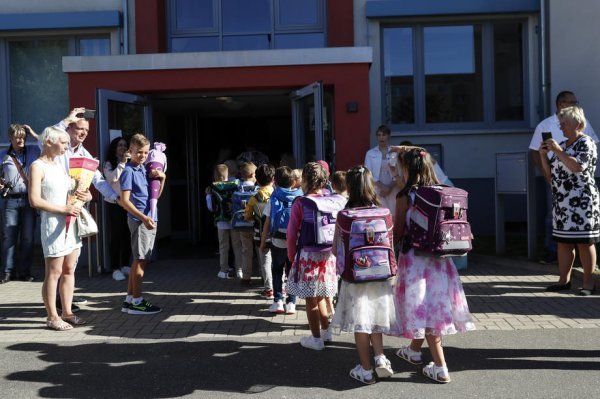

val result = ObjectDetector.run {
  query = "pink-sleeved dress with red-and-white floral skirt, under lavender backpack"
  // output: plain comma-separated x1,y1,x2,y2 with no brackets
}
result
286,195,337,298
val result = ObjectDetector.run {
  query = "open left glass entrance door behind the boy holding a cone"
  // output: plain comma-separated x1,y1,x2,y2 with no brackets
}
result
96,89,152,272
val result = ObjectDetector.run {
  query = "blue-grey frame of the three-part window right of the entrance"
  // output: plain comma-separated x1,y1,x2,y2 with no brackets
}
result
379,17,531,134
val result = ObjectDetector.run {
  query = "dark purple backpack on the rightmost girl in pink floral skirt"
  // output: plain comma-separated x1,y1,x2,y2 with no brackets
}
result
407,185,473,256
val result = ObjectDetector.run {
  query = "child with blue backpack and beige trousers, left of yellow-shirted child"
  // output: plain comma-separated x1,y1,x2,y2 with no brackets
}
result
231,162,256,287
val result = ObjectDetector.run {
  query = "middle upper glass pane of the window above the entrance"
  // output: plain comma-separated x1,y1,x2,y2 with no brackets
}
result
221,0,271,33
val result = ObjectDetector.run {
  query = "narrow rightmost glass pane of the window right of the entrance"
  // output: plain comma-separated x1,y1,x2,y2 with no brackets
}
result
494,23,525,121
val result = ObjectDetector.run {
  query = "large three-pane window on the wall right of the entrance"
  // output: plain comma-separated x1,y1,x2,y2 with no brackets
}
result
382,21,526,130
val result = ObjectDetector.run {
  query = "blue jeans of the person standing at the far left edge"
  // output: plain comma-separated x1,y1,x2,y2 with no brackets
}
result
2,196,36,277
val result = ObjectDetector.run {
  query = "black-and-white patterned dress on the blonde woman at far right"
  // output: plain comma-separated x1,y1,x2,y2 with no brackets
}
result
550,135,600,243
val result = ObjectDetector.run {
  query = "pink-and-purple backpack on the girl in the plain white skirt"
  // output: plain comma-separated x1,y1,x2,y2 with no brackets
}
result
336,207,397,283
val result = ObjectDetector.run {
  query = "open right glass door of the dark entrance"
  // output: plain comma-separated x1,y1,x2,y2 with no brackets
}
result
291,81,335,167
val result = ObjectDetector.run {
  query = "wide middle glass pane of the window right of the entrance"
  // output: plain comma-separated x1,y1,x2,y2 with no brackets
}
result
424,25,483,123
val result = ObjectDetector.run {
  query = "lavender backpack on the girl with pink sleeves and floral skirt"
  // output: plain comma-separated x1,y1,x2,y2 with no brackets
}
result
297,194,347,253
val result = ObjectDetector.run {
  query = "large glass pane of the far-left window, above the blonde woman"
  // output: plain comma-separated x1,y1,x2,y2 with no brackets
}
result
8,40,69,133
